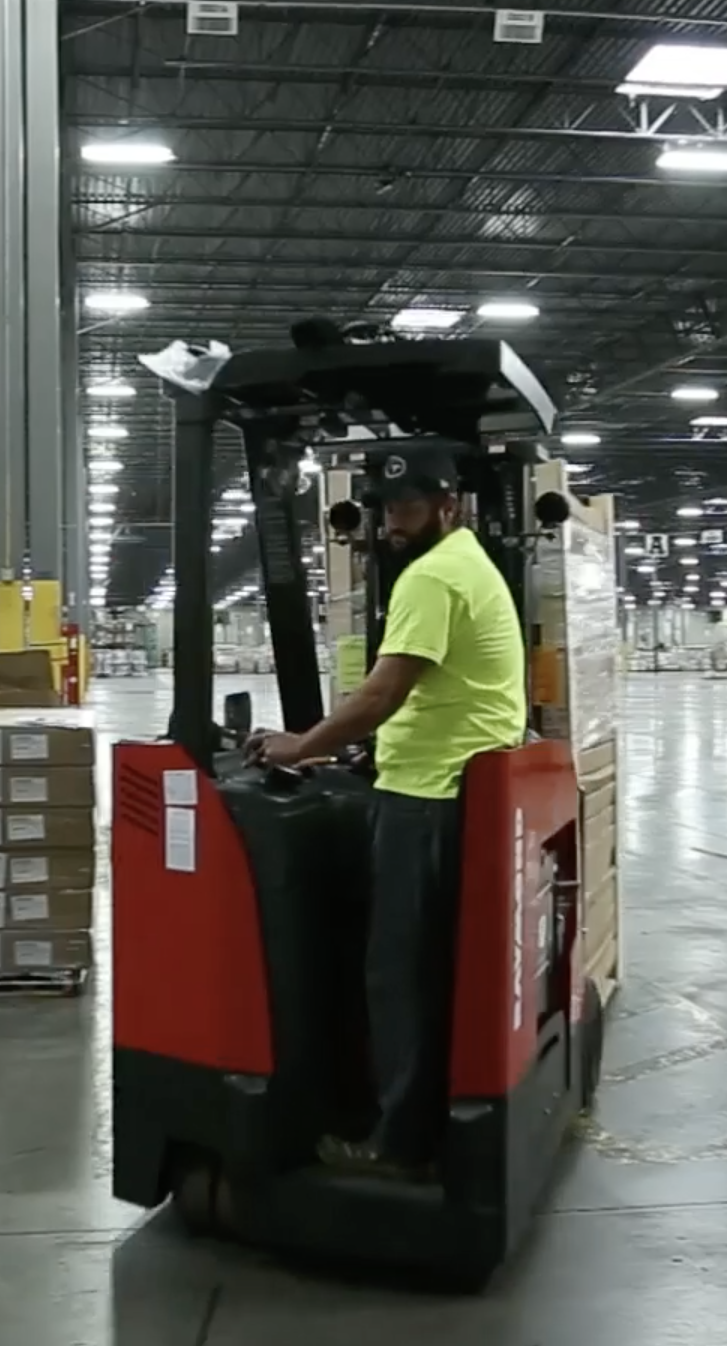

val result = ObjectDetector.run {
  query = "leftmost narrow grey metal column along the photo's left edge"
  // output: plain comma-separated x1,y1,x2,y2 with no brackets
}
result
0,0,27,578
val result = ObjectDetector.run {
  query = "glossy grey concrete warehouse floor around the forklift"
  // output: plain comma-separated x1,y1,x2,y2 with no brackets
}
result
0,674,727,1346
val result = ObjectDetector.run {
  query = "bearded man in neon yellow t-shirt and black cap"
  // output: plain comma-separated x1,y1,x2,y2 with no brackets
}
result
260,451,526,1171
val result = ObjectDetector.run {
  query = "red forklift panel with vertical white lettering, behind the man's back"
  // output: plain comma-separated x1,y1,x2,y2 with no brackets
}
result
450,742,578,1098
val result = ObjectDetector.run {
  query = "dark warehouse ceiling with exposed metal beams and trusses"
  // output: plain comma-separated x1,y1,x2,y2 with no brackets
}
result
61,0,727,603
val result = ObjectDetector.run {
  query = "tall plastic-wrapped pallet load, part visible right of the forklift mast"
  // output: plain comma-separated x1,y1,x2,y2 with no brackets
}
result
533,462,623,1004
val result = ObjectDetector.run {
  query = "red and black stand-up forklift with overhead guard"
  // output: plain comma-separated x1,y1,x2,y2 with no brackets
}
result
113,322,602,1287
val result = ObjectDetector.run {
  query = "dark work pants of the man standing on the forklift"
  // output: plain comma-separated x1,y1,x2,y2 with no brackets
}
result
366,790,459,1164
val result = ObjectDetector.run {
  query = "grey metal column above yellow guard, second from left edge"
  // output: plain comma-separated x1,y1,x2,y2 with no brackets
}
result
24,0,63,579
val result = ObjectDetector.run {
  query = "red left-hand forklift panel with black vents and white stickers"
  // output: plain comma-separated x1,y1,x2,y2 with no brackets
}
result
112,743,273,1075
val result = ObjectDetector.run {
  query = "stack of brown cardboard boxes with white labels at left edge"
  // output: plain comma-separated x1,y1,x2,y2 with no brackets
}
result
0,723,94,980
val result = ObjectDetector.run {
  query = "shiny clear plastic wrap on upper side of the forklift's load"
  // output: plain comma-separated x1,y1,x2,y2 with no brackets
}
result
564,518,619,760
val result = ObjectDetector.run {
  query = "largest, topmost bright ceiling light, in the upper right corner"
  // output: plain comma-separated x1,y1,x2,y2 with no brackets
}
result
617,42,727,101
